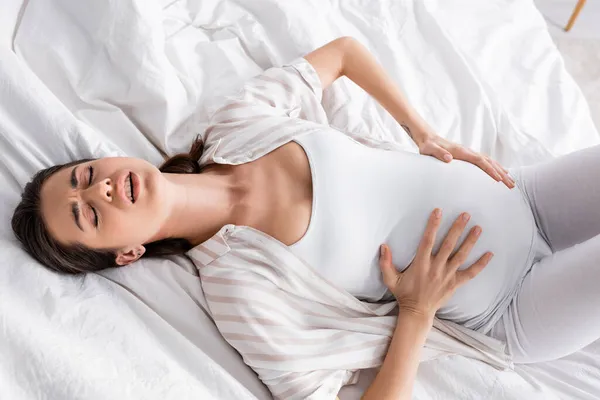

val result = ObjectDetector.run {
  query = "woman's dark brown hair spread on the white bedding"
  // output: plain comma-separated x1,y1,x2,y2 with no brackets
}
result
11,137,204,274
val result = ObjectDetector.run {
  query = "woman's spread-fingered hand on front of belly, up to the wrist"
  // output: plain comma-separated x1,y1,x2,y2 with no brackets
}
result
379,209,493,320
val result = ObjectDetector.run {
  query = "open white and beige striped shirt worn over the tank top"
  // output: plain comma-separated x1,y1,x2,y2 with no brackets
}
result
188,58,513,399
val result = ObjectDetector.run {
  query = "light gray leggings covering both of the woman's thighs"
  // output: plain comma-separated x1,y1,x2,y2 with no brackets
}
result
488,145,600,363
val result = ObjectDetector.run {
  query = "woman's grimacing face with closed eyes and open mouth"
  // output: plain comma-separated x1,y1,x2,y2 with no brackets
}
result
41,157,168,264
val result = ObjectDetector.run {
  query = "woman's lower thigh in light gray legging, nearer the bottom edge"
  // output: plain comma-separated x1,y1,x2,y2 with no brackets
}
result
488,235,600,363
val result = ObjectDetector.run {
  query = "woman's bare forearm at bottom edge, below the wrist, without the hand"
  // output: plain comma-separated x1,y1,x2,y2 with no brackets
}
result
362,311,433,400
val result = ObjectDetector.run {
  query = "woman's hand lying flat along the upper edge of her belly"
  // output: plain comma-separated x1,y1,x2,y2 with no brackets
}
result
415,134,515,189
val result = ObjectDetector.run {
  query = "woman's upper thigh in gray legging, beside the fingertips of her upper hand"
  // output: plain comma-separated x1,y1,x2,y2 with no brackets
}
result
509,145,600,252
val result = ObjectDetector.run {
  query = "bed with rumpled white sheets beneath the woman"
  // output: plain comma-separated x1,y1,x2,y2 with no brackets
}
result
0,0,600,400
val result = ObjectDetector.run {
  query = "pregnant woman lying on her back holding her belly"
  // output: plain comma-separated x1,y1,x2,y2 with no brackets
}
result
12,38,600,399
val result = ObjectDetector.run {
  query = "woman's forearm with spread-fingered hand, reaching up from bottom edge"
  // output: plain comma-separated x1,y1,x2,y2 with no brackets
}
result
363,209,492,400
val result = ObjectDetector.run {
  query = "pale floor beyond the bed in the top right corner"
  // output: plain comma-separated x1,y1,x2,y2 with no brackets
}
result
534,0,600,130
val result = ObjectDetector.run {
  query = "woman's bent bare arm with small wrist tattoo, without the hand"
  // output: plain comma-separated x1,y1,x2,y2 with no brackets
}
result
304,37,433,145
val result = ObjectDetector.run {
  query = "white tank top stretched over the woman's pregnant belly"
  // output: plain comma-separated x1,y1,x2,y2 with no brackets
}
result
289,130,535,322
